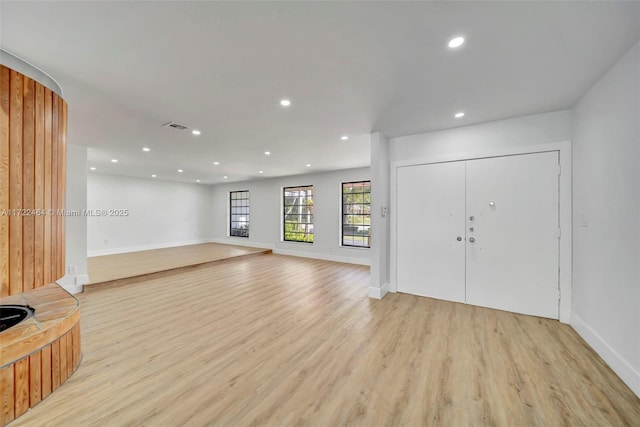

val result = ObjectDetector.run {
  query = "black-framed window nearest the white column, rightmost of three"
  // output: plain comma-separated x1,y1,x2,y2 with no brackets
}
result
342,181,371,248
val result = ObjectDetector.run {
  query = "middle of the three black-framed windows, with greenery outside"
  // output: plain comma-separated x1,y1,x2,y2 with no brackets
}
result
283,185,313,243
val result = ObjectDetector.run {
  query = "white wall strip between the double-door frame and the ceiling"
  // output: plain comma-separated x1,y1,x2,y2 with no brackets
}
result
389,111,571,162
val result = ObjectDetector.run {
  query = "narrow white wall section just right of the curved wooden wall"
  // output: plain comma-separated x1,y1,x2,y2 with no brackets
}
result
58,144,88,293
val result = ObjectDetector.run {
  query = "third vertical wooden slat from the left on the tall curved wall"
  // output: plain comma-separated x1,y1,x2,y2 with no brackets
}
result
22,77,36,291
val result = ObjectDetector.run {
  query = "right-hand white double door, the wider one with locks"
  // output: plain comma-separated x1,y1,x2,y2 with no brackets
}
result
466,152,559,319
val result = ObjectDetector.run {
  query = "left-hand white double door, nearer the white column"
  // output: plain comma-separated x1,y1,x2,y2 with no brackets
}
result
396,162,465,302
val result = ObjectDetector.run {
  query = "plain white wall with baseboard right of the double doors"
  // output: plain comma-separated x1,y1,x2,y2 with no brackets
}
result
572,44,640,395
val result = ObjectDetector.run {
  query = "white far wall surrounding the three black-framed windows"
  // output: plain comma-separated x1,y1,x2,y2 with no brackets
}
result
211,168,375,265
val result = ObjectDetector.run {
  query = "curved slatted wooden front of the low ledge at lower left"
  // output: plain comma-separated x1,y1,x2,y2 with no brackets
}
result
0,323,80,425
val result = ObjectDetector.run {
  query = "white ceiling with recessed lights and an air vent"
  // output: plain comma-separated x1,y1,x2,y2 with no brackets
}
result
0,1,640,183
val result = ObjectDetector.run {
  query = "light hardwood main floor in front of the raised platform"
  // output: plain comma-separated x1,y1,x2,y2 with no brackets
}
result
11,255,640,427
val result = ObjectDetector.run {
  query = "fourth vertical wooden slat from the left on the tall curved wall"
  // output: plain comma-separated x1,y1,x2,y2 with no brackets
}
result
34,84,48,287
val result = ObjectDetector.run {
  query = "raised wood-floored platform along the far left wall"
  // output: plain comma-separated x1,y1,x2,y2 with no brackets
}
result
86,243,271,286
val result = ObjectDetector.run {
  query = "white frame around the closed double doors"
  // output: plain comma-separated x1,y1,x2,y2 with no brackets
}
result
389,141,572,323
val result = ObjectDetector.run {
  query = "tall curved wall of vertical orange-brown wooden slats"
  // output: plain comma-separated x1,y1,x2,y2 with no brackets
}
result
0,65,67,297
